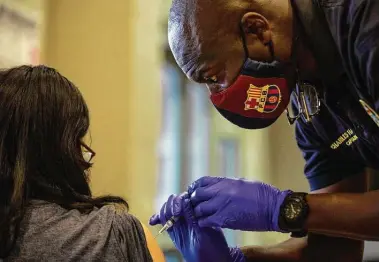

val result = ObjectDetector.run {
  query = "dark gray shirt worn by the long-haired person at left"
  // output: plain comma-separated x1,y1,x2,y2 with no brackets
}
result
0,201,152,262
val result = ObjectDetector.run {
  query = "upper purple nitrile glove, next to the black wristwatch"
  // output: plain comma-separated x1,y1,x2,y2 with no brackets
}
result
188,177,291,232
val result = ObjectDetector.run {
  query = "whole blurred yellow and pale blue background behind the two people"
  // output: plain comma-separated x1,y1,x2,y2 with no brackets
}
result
0,0,378,261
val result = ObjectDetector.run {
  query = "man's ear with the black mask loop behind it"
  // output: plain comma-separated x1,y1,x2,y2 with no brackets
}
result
241,12,272,45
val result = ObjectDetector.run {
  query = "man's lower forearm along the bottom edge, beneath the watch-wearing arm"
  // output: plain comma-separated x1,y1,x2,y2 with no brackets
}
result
241,234,364,262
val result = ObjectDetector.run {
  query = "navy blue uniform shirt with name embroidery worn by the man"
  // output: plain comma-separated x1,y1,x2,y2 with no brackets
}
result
296,0,379,190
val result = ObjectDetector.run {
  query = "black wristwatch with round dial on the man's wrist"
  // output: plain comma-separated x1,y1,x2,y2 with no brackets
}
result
279,193,309,238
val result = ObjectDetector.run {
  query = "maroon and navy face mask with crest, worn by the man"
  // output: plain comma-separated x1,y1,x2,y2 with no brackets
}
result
210,58,291,129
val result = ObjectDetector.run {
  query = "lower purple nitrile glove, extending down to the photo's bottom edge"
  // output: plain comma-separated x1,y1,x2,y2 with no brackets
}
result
149,193,245,262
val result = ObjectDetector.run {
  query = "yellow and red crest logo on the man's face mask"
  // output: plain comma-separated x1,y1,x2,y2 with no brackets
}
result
245,84,282,113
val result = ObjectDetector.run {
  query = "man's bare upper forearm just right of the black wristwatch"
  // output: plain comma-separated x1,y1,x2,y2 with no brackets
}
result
306,191,379,240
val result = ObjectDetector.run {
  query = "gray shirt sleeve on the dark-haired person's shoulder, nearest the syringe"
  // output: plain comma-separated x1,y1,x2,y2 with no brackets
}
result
112,210,153,262
